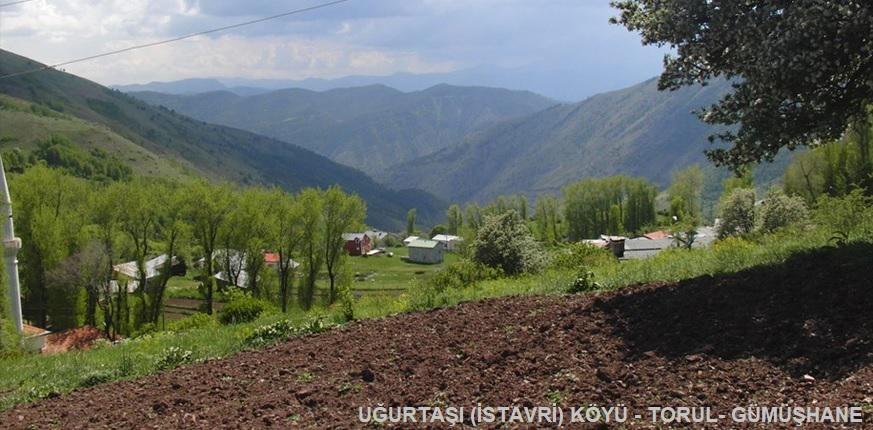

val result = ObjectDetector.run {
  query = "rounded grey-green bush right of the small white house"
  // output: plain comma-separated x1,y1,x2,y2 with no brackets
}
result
472,210,546,275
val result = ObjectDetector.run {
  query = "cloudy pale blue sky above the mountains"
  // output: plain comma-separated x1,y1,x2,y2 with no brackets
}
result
0,0,664,98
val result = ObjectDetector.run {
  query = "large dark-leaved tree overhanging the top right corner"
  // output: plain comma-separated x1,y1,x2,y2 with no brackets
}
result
612,0,873,168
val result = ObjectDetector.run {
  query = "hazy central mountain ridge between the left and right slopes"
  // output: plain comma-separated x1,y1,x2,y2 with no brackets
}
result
131,85,554,176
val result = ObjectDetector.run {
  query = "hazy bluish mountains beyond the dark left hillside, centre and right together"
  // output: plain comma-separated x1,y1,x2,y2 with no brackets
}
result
126,73,760,202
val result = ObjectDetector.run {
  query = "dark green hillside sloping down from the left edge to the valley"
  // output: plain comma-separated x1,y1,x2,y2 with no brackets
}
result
0,50,445,229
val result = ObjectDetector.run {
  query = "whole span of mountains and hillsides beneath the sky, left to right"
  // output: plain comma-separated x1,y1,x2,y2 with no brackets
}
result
0,51,788,228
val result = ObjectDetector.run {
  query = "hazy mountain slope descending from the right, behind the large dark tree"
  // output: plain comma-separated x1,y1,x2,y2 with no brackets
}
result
384,79,792,201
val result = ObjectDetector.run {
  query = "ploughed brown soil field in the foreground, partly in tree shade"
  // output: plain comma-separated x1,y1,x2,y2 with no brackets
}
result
6,244,873,428
